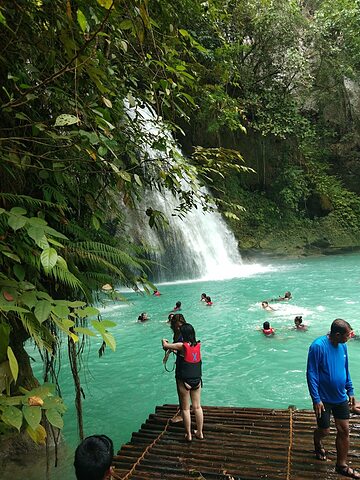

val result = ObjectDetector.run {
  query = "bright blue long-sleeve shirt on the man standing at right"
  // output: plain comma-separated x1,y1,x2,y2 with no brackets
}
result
306,336,354,404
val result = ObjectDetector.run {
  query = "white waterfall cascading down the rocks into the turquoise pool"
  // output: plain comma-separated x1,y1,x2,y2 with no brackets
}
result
127,101,268,282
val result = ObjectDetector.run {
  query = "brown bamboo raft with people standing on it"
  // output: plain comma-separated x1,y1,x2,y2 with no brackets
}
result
113,405,360,480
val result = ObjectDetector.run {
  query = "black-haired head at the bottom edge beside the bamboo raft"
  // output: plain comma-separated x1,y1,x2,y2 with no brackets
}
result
74,435,114,480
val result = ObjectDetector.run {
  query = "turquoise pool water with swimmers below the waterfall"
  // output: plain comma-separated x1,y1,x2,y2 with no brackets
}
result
5,255,360,480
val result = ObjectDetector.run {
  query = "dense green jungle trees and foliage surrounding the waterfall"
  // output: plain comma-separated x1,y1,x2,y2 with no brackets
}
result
0,0,360,450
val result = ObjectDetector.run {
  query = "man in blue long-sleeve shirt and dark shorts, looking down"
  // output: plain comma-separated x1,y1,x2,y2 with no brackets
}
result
306,318,360,479
